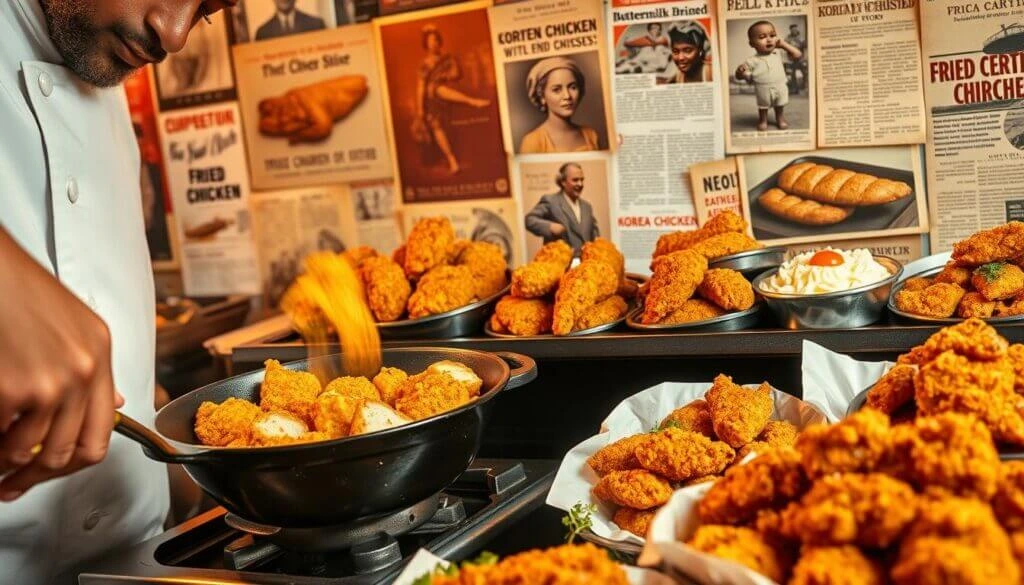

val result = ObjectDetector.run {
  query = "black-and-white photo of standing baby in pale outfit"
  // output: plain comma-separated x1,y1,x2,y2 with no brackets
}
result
726,14,810,133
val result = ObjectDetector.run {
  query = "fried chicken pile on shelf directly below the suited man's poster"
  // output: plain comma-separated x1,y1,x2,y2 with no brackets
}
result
490,238,637,336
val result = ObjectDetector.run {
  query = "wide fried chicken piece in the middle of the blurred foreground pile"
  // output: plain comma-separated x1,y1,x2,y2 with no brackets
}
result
779,473,918,548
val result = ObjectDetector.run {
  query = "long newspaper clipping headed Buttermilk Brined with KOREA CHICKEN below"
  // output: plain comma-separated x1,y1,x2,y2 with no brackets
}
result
609,0,725,273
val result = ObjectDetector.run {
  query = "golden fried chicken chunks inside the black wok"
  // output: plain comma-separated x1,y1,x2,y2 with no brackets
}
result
195,360,483,448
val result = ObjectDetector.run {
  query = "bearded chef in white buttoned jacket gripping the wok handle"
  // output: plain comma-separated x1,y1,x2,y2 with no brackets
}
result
0,0,234,585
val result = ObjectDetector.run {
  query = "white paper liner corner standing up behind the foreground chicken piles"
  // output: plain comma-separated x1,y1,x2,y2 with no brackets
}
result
800,339,894,422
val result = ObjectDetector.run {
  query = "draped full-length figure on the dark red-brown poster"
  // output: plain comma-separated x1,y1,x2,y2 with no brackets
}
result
413,25,490,174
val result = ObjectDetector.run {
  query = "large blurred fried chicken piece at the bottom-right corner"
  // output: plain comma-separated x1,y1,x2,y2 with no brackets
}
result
890,497,1020,585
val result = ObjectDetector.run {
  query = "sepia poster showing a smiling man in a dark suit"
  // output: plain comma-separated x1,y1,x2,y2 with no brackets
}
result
515,153,611,258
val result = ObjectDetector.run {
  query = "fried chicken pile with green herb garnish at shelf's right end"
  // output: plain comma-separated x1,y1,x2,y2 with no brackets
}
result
893,221,1024,319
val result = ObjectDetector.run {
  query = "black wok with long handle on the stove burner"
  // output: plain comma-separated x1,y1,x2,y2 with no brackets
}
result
115,348,537,528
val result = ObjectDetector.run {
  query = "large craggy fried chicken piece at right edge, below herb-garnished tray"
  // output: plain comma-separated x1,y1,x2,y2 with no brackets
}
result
914,351,1024,445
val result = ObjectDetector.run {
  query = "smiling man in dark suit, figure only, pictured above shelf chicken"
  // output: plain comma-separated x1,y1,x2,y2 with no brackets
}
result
526,163,601,254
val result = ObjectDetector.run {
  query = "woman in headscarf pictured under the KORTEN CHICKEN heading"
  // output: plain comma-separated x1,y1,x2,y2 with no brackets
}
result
519,56,601,154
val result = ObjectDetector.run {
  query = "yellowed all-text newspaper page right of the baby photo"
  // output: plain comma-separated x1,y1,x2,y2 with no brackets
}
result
813,0,933,149
